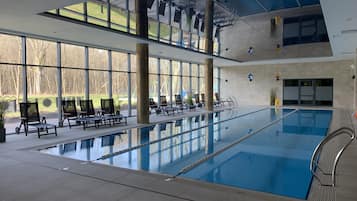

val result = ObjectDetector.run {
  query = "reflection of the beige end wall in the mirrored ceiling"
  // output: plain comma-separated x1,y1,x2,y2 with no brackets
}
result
221,7,332,61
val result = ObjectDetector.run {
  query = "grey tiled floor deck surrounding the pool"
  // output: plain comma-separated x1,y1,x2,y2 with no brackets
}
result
0,107,357,201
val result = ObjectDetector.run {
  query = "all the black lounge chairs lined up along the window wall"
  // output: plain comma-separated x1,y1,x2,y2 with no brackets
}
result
16,93,234,138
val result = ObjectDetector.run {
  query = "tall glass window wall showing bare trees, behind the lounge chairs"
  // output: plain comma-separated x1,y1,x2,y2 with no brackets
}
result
0,34,219,133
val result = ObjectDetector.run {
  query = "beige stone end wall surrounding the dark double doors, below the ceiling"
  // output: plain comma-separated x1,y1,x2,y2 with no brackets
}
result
221,60,354,108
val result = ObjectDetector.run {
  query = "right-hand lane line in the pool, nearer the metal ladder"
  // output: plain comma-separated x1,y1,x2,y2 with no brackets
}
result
165,109,299,181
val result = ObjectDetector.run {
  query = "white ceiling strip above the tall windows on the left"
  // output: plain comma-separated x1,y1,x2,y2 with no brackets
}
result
0,0,239,66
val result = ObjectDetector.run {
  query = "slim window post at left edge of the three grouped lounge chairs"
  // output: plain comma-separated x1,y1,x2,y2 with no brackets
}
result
57,42,63,127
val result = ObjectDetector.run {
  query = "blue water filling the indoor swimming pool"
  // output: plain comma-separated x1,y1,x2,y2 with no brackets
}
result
41,108,332,199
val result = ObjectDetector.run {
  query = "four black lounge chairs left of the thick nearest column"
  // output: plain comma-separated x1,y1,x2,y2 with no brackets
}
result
16,99,127,138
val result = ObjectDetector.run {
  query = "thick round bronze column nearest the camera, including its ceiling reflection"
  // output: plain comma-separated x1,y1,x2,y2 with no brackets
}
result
135,0,150,124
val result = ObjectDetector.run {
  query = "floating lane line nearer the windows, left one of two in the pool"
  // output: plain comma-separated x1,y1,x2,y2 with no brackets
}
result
93,107,271,162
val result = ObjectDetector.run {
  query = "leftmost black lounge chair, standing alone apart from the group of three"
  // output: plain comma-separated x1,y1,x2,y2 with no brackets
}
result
16,102,57,138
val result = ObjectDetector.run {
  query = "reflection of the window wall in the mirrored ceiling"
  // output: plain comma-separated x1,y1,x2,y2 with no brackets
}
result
48,0,220,55
